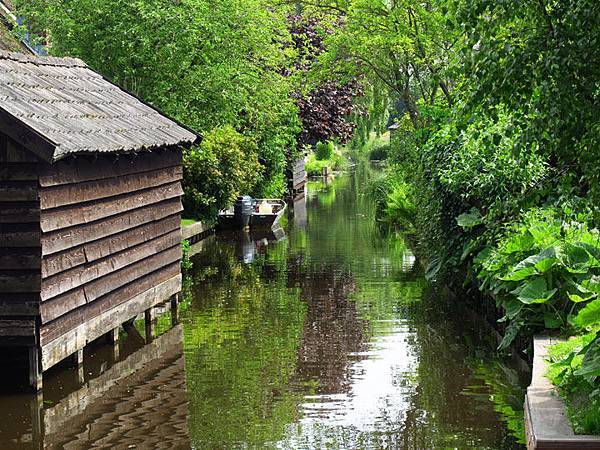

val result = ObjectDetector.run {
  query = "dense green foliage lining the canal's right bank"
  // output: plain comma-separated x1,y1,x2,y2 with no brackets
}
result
290,0,600,428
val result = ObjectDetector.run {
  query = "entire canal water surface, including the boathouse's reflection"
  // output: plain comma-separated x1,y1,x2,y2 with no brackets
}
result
0,163,528,449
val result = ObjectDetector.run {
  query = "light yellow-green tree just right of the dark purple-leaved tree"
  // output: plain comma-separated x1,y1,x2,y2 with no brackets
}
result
292,0,460,128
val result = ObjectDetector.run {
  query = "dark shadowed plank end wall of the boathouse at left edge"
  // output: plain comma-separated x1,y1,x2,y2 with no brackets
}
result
0,134,41,345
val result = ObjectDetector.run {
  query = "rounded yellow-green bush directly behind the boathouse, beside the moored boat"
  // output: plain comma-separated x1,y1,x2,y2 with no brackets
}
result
183,126,263,219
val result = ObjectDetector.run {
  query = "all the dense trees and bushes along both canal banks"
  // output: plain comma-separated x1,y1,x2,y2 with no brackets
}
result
12,0,600,432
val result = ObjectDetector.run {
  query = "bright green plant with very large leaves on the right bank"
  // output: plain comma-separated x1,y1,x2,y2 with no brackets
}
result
476,208,600,348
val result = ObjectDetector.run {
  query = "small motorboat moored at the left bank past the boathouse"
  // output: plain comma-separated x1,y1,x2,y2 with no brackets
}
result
219,196,287,230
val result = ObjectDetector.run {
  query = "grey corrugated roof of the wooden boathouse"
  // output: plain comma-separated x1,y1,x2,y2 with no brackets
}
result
0,51,198,161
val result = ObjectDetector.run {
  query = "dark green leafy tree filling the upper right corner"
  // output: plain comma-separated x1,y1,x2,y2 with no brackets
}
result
456,0,600,199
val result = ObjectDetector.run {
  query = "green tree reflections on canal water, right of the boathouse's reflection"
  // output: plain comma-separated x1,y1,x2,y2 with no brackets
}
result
186,165,520,449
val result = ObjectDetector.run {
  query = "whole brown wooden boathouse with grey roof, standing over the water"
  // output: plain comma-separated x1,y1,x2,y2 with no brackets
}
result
0,51,198,389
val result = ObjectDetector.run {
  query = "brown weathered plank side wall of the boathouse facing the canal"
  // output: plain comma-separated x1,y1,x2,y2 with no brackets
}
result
39,149,183,370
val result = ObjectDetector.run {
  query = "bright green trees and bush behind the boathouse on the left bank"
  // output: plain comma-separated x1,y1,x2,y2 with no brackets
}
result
17,0,308,220
